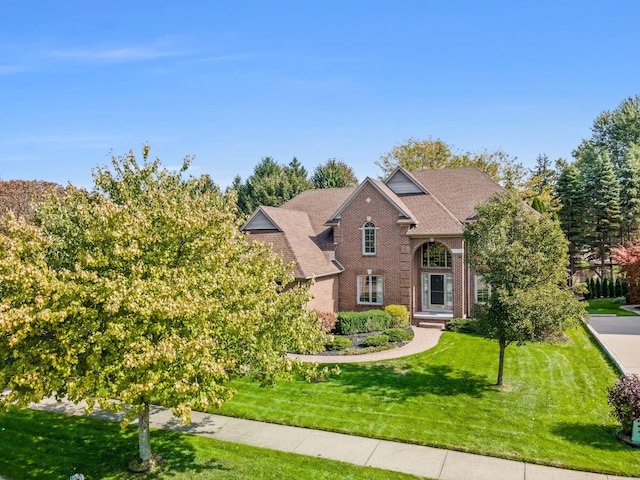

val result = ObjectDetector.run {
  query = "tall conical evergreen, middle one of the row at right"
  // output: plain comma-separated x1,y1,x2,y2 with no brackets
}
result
585,152,620,279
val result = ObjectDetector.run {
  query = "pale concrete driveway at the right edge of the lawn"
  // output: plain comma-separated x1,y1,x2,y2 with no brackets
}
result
589,315,640,375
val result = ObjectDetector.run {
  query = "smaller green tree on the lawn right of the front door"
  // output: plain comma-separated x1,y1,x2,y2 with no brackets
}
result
464,191,584,385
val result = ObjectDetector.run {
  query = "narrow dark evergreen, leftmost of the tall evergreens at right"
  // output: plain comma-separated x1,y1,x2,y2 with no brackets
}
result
556,165,593,280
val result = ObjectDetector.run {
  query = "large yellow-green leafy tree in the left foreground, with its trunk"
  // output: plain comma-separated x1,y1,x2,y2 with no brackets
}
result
0,146,323,460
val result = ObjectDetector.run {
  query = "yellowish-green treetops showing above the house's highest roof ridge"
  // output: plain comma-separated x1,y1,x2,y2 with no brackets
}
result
376,137,517,186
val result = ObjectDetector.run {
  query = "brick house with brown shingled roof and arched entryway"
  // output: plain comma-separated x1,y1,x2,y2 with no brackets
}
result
242,167,502,323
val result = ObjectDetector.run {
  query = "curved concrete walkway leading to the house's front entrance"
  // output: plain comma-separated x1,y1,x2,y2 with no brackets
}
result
290,327,443,363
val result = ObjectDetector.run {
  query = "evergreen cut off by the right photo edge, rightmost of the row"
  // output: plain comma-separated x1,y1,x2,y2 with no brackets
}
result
619,144,640,243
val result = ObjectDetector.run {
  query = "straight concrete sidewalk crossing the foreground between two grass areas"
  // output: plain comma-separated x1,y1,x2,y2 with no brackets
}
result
31,399,627,480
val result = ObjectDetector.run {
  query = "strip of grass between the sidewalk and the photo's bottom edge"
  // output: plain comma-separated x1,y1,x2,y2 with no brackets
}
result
0,410,430,480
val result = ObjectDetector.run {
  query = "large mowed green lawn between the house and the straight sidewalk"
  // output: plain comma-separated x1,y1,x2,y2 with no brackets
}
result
219,327,640,475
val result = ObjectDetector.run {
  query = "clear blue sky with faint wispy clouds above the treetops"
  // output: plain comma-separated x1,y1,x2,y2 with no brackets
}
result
0,0,640,187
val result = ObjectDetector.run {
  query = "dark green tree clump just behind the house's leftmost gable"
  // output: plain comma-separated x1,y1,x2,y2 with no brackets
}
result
232,157,311,215
